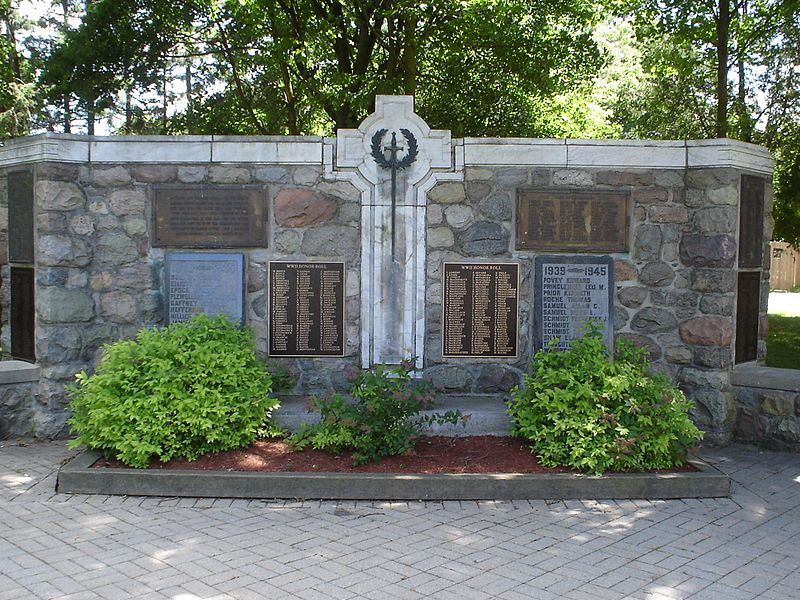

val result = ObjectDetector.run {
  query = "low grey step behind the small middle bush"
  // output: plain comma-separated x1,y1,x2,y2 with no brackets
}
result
274,394,511,437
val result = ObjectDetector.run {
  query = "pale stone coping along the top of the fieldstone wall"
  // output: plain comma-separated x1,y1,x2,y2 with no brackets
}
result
0,133,774,175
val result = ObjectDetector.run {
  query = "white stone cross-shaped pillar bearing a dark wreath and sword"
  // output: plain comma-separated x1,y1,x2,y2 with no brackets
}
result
325,96,463,368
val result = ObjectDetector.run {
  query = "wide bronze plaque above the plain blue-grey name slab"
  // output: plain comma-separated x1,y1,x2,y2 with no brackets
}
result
153,185,267,248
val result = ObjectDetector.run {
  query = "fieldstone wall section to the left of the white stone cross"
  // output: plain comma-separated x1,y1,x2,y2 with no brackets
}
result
2,157,360,438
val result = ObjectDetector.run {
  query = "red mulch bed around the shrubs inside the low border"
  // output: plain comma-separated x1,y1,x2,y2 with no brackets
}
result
93,435,695,473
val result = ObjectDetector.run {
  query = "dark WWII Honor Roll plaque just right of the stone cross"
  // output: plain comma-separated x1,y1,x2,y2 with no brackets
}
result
442,263,519,358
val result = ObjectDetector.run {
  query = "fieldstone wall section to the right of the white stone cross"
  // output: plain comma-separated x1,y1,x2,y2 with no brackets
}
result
426,167,771,443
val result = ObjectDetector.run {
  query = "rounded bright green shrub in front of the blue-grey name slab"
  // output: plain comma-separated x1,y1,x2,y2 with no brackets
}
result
69,315,278,467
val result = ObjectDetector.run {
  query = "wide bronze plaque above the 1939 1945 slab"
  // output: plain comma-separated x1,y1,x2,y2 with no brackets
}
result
517,190,629,252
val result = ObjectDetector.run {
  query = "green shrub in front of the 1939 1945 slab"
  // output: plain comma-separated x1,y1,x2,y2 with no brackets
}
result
508,324,703,474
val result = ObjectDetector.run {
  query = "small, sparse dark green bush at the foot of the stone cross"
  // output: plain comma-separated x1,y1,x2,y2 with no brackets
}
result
287,361,462,465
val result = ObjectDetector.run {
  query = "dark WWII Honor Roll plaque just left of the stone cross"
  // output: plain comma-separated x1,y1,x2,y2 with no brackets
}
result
269,262,345,356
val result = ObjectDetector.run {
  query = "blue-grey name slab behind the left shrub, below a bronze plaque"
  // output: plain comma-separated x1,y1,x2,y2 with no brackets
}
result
166,252,244,324
